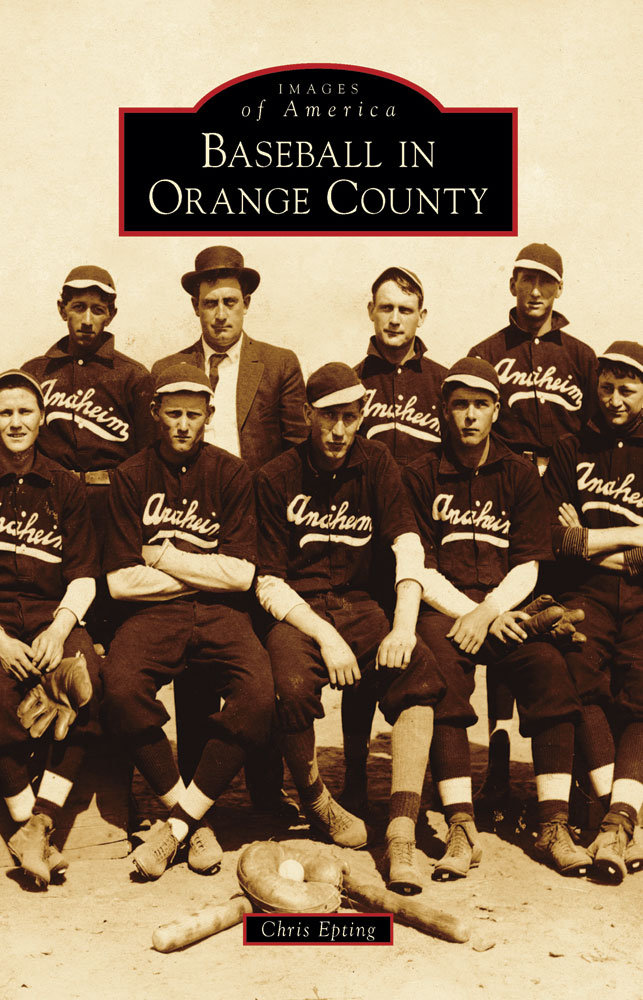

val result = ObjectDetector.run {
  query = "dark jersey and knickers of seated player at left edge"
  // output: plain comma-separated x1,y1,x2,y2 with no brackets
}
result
0,451,100,764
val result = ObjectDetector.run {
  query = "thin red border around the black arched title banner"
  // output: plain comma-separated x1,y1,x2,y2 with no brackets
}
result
118,63,518,237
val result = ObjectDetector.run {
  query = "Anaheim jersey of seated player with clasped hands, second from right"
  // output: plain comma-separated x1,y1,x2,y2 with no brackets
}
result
403,435,552,593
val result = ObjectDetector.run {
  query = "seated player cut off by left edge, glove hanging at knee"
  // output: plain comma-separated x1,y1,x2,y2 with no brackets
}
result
0,370,99,887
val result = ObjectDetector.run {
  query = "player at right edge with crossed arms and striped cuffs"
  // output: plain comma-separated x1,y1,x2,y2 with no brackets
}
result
544,340,643,882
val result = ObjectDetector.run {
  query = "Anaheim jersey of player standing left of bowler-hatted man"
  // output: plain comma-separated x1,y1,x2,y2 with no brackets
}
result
22,333,156,472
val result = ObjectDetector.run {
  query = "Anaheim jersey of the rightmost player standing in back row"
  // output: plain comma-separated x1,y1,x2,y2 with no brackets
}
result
469,309,597,455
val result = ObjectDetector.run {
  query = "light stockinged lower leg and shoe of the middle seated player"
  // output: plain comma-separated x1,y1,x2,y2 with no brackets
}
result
386,705,433,895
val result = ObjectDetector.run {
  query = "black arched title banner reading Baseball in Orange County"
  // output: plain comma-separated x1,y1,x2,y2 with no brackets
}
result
120,64,517,236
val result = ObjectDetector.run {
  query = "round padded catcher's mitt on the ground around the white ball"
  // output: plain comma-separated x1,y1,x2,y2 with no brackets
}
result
237,840,348,913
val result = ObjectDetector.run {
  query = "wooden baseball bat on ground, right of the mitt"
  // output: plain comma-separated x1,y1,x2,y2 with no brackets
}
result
344,874,471,944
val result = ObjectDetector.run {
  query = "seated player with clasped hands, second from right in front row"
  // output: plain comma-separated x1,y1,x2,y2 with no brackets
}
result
404,358,591,880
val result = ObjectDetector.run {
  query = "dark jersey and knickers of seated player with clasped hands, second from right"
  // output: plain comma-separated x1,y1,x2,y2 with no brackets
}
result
403,435,577,736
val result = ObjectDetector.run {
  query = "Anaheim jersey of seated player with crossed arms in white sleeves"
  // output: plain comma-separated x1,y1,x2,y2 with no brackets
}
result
105,444,256,573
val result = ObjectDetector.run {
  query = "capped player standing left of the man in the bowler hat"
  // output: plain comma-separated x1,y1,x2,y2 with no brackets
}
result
23,264,155,646
